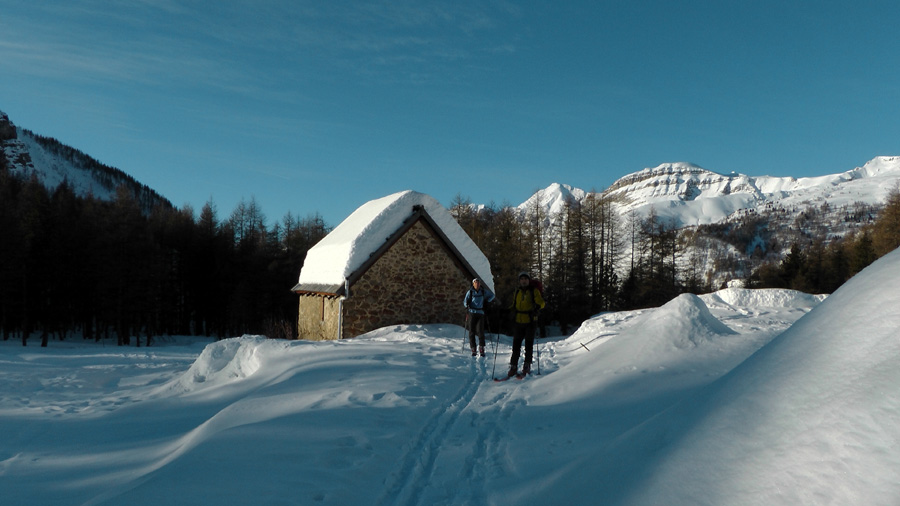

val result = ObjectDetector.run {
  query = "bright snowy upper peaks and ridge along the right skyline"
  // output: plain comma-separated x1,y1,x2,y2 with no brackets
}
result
518,156,900,228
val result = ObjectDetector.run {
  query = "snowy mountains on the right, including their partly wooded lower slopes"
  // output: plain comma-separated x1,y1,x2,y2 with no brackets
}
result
517,156,900,286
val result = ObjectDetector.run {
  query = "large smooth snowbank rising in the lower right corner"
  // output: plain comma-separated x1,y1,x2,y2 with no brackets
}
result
592,250,900,504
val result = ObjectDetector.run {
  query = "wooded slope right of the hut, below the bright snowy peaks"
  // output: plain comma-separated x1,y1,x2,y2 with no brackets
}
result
451,190,900,332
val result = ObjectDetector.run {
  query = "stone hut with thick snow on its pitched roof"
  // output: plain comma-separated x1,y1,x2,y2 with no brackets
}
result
293,191,494,340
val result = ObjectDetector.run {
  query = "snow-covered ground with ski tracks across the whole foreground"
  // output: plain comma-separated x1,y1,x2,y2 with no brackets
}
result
0,248,900,506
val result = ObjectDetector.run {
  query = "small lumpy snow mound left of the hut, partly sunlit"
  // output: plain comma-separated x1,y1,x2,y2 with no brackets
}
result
162,336,267,394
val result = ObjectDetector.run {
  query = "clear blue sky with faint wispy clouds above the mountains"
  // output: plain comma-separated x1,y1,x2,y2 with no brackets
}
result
0,0,900,225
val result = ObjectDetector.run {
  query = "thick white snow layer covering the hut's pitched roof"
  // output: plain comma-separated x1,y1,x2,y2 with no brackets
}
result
295,190,494,293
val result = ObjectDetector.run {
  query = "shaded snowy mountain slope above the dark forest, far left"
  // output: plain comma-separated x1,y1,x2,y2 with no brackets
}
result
0,111,171,210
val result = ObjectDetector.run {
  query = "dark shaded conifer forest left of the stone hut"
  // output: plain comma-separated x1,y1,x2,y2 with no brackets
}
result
0,170,328,345
